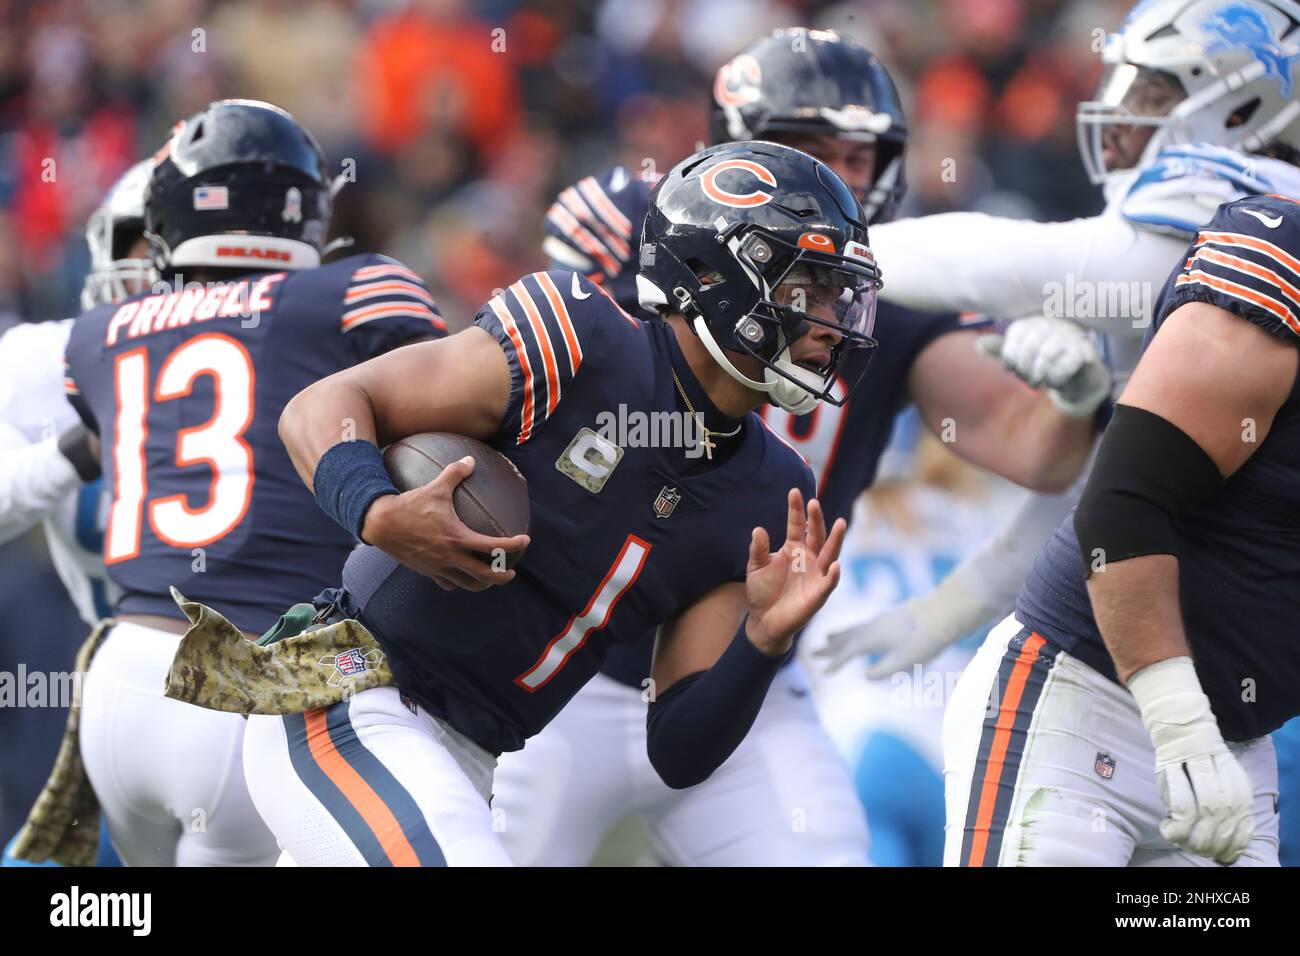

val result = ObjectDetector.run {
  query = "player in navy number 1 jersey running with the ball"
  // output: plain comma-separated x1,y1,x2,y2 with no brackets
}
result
244,143,879,865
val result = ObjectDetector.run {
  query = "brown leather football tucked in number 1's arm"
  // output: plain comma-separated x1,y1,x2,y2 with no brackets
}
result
384,432,529,567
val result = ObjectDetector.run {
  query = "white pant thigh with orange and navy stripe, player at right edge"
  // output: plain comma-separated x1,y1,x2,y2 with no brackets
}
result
944,617,1153,866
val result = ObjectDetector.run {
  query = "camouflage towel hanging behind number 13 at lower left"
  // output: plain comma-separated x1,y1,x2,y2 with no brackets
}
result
13,620,113,866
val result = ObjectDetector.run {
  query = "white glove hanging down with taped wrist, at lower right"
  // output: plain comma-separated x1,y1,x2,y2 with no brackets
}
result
1128,657,1255,864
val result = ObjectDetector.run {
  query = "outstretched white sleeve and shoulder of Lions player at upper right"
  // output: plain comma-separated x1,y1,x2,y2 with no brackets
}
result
871,144,1300,385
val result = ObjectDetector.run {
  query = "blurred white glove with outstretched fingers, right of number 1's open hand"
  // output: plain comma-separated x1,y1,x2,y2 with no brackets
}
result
814,575,989,680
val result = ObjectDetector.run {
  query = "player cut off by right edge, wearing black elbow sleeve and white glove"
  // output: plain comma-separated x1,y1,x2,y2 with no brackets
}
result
944,196,1300,866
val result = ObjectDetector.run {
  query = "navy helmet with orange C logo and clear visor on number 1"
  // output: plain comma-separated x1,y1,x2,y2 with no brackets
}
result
637,142,880,415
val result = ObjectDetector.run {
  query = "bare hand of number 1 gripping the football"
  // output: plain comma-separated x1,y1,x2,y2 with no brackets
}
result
361,458,529,591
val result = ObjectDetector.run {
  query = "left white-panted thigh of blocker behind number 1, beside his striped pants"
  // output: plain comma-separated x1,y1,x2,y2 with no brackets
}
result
491,674,644,866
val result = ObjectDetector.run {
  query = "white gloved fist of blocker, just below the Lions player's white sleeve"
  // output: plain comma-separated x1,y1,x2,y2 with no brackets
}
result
978,316,1110,419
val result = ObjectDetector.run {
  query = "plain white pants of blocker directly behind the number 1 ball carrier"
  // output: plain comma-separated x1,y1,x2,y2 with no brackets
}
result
493,665,867,866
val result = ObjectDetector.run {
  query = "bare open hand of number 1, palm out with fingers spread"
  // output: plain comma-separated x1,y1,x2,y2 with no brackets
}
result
745,488,848,656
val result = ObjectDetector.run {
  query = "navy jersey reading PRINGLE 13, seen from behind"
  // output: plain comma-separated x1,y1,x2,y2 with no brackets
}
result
66,255,445,631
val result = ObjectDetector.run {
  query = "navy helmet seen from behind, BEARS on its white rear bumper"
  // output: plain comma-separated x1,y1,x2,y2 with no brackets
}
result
144,100,332,273
